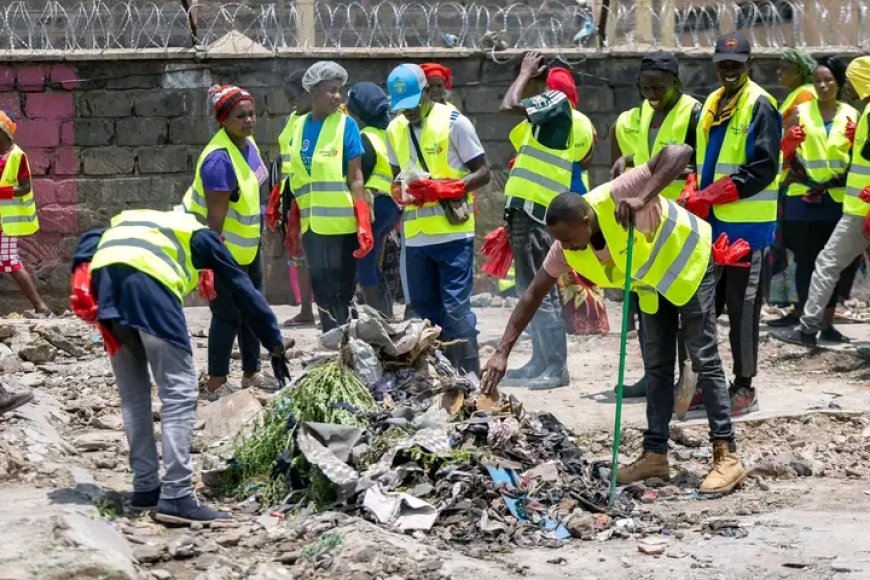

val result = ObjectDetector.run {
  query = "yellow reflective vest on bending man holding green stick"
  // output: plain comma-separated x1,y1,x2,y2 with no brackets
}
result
564,184,712,314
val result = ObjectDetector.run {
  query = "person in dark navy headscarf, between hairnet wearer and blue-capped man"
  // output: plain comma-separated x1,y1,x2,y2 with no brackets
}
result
347,82,399,317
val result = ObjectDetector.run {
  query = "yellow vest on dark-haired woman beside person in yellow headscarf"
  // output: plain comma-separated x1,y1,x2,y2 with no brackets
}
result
787,100,858,203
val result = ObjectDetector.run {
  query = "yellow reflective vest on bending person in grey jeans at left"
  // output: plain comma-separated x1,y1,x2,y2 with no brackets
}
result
91,210,207,302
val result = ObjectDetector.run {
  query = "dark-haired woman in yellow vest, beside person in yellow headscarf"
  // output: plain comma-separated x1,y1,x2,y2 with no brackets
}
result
768,56,858,342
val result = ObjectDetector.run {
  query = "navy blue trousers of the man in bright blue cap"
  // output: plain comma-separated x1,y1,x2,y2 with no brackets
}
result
406,238,477,340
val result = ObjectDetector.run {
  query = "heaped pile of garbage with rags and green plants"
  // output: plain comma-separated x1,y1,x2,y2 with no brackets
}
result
228,306,648,545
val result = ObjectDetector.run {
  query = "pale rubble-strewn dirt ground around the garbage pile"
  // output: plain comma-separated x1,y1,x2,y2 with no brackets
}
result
0,304,870,580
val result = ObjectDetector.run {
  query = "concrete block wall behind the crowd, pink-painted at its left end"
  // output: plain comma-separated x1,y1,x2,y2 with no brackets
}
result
0,54,848,311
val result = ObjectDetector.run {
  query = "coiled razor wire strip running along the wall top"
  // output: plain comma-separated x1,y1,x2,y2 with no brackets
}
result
0,0,870,52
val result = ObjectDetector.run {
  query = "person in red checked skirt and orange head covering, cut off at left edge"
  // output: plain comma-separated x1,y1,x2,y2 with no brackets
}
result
0,111,51,316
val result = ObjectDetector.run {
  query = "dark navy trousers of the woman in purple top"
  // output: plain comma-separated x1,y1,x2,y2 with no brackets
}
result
208,245,263,377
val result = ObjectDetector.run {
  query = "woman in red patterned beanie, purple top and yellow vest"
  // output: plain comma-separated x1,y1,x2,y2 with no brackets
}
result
183,85,275,401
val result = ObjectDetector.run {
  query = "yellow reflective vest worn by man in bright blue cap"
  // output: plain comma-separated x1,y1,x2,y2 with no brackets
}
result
387,103,474,246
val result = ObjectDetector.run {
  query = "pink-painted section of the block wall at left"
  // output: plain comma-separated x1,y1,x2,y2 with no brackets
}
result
0,64,79,282
